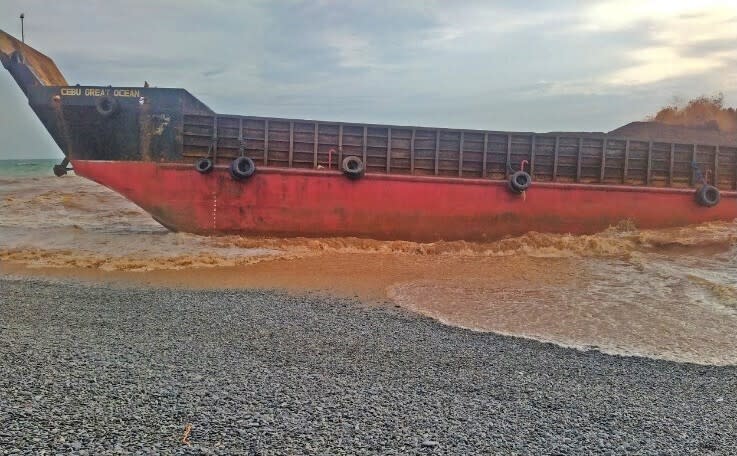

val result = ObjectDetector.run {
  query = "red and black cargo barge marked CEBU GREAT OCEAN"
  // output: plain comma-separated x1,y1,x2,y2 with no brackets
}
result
0,31,737,241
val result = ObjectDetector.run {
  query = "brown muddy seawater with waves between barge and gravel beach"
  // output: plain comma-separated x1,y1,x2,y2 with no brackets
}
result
0,162,737,365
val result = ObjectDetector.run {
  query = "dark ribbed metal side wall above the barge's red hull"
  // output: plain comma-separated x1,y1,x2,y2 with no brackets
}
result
183,115,737,190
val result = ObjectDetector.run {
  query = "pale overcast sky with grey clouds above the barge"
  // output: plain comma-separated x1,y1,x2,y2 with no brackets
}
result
0,0,737,159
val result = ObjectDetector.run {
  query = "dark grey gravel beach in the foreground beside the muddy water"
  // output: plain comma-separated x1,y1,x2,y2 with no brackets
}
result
0,278,737,455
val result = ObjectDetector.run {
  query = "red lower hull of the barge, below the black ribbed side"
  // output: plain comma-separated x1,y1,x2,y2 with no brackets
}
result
74,160,737,241
